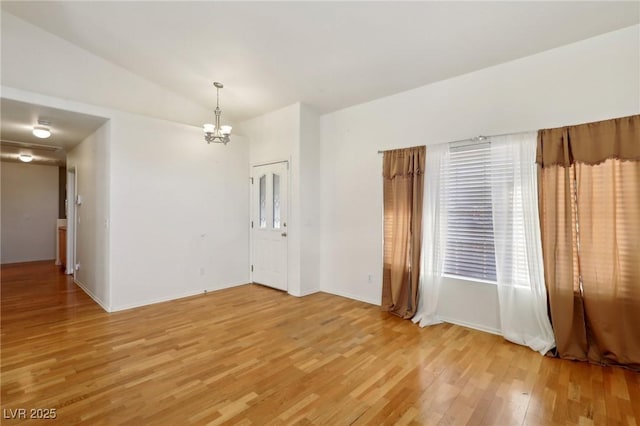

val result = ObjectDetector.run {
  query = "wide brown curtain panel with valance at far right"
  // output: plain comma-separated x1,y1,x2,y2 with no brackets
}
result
537,115,640,369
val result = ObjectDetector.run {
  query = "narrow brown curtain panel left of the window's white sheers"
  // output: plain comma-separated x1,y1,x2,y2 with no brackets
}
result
382,146,426,319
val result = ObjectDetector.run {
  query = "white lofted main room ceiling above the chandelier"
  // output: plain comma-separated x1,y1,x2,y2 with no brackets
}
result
2,1,640,125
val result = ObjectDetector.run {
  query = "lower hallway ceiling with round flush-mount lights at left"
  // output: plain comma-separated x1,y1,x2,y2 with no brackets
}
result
0,98,107,165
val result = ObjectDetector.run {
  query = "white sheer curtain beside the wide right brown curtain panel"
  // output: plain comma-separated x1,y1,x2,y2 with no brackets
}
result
490,132,555,354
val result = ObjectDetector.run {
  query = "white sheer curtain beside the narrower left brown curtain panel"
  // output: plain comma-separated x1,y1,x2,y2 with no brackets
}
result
412,144,449,327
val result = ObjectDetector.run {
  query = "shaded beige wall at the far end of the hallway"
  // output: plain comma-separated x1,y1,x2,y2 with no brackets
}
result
0,162,58,263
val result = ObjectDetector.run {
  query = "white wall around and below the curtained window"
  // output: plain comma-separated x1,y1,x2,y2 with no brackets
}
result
320,25,640,331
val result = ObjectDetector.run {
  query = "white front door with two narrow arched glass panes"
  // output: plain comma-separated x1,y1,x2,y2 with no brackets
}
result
251,162,289,291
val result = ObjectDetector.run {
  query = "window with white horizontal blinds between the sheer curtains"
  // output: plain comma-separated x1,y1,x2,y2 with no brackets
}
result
440,142,496,282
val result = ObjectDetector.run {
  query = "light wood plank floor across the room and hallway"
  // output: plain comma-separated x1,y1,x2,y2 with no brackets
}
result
1,262,640,426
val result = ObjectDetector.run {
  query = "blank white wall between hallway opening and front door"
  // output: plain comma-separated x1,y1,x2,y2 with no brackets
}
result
110,115,249,310
